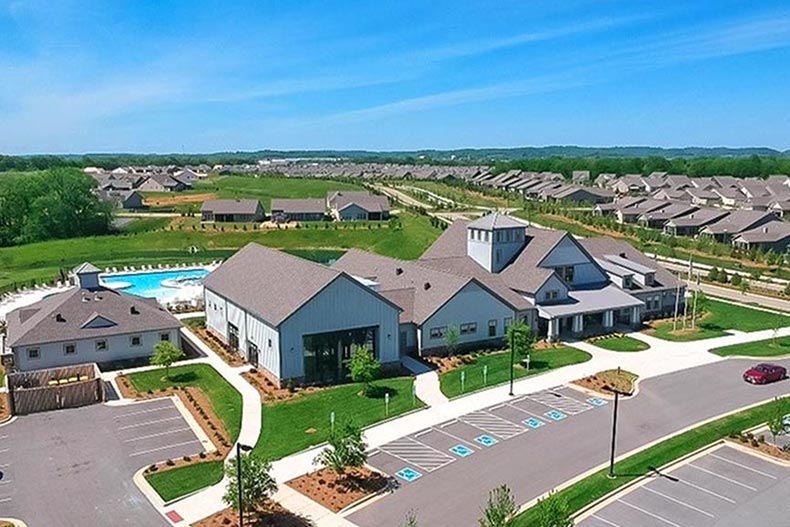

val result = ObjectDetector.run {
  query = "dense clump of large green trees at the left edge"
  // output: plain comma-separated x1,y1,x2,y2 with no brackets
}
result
0,168,112,247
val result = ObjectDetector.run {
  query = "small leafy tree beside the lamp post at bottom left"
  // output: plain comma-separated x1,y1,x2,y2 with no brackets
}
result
222,454,277,514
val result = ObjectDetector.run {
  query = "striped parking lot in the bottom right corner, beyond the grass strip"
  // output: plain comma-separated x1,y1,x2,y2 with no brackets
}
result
578,446,790,527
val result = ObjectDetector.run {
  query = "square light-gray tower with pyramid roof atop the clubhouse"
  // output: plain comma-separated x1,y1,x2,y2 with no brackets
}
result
466,212,527,273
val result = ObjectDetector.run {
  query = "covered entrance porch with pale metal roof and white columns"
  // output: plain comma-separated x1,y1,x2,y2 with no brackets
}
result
537,285,645,342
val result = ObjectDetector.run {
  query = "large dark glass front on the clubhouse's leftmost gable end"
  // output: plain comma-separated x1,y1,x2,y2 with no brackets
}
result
302,327,378,383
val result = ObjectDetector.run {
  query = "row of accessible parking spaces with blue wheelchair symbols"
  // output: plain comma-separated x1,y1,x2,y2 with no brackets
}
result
369,387,608,484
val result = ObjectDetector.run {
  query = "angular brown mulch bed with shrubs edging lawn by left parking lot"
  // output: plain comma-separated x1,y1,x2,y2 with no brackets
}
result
116,375,232,474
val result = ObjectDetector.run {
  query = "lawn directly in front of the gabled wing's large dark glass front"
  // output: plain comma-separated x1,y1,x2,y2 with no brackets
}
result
254,377,423,460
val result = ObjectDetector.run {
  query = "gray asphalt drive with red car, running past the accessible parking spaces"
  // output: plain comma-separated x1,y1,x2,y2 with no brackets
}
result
348,360,790,527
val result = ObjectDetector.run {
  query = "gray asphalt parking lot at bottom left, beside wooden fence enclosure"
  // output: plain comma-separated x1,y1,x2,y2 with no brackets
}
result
0,399,204,527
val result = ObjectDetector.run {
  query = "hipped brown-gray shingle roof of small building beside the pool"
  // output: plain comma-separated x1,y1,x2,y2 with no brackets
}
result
7,288,181,346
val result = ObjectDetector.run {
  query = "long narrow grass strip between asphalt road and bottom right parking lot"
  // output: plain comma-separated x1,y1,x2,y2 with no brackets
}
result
515,400,790,527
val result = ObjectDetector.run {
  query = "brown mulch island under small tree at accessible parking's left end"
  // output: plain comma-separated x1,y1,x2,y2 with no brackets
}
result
286,467,390,512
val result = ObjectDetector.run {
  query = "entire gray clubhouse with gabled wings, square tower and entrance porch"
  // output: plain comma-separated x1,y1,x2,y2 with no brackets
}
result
204,213,685,383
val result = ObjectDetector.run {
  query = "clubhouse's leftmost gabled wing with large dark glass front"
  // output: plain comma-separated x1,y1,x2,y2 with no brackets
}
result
204,243,401,386
